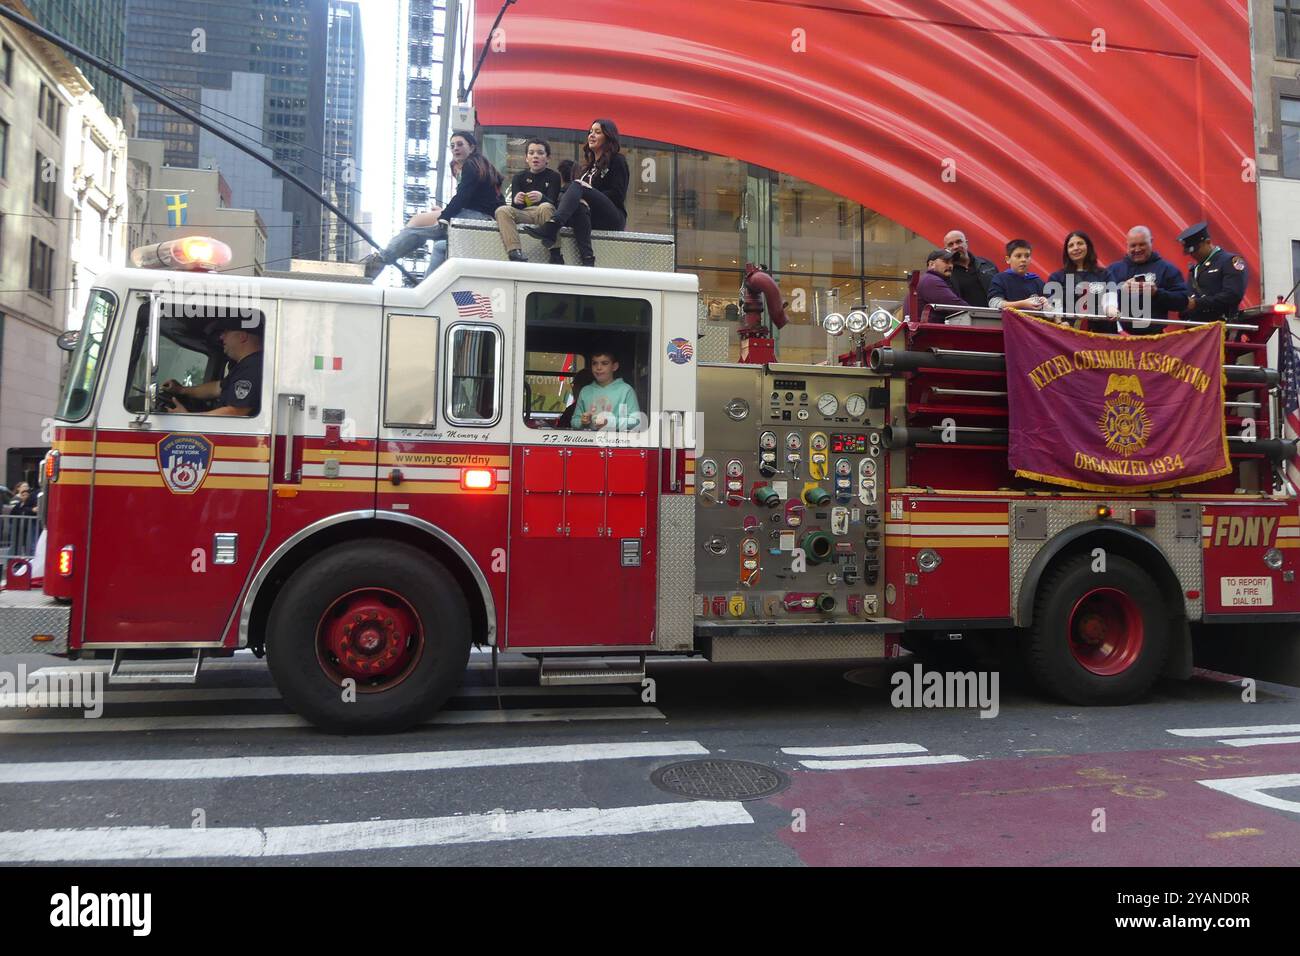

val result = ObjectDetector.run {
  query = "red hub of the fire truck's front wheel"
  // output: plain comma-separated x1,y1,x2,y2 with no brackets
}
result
316,588,424,691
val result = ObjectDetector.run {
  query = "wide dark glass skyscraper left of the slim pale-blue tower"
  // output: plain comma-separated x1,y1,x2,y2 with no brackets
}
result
126,0,329,257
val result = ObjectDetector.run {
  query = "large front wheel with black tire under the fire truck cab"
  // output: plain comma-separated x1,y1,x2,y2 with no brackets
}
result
267,541,471,734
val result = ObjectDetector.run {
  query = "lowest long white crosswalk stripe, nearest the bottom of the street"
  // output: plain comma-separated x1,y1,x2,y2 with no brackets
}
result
0,800,754,862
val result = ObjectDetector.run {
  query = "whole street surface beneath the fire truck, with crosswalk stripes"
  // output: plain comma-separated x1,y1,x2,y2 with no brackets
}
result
0,654,1300,866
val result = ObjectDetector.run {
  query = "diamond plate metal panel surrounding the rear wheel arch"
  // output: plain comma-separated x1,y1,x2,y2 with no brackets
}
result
1011,498,1205,623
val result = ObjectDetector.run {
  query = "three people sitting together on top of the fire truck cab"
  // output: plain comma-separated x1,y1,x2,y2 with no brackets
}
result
365,120,629,278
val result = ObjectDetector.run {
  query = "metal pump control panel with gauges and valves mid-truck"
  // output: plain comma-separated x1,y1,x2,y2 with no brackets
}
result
696,364,887,623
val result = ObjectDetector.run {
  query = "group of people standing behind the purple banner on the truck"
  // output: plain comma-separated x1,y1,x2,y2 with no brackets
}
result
917,222,1247,334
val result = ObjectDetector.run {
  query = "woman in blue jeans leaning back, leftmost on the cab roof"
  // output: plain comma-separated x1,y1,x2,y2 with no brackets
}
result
365,133,504,278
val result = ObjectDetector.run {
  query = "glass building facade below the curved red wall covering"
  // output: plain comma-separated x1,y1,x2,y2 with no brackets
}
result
484,127,932,363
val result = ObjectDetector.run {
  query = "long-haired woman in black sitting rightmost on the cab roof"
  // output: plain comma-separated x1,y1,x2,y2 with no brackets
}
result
524,120,631,265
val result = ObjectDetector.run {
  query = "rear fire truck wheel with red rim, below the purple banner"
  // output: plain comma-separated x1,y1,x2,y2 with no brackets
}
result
1026,554,1170,704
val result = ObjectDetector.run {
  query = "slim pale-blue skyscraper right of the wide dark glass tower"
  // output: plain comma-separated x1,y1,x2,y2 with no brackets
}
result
321,0,365,261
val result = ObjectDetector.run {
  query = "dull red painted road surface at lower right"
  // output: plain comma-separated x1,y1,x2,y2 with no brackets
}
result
775,745,1300,866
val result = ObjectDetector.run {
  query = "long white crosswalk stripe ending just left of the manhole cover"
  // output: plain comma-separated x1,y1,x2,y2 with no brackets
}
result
0,740,709,784
